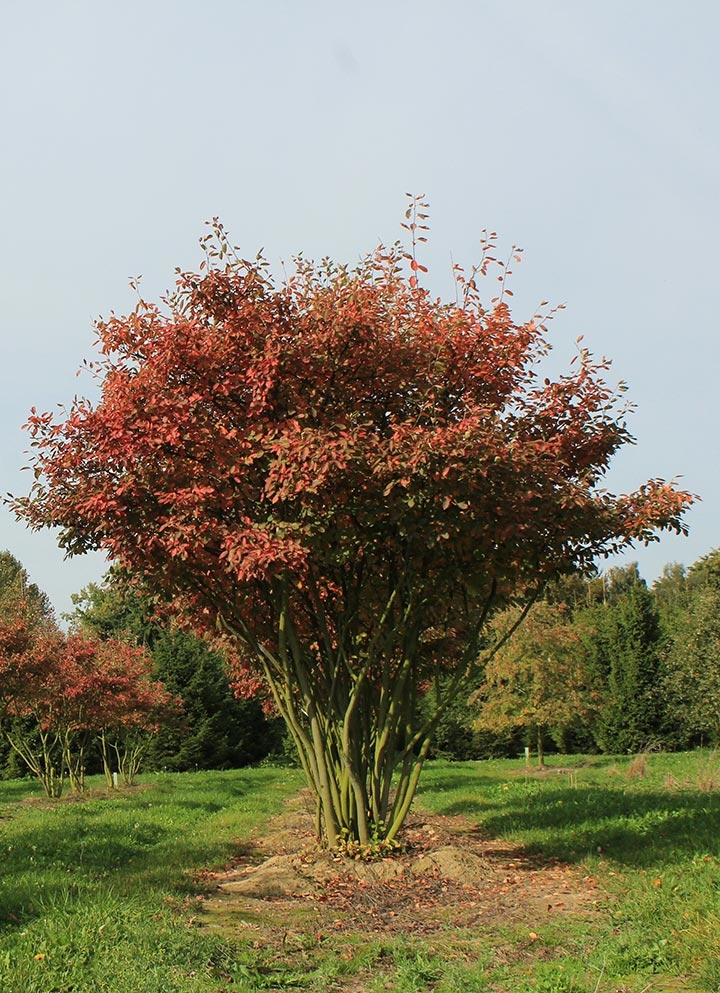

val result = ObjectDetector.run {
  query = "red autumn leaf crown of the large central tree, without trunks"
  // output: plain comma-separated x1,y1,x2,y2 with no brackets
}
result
15,214,691,672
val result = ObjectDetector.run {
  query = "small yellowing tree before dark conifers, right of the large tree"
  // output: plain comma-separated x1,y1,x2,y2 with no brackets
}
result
470,601,602,766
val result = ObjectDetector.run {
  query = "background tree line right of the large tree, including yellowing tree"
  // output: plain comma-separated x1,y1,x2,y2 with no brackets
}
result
424,550,720,762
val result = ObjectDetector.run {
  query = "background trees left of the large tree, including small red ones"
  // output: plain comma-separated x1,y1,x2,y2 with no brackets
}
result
0,551,285,792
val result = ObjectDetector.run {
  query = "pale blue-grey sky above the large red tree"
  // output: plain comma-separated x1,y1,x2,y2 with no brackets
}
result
0,0,720,613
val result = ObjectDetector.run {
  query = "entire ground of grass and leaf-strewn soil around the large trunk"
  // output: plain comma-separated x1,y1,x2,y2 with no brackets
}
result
0,751,720,993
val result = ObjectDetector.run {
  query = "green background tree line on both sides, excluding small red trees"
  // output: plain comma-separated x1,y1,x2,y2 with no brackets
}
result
0,550,720,776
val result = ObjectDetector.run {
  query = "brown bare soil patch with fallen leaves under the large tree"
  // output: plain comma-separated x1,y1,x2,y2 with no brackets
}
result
204,792,605,944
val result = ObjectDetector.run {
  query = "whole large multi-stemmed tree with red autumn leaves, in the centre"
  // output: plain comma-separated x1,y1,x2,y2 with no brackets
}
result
13,207,692,846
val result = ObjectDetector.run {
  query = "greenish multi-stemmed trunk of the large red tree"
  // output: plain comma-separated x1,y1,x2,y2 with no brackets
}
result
222,579,494,853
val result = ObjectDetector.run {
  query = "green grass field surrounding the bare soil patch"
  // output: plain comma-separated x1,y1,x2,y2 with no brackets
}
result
0,753,720,993
